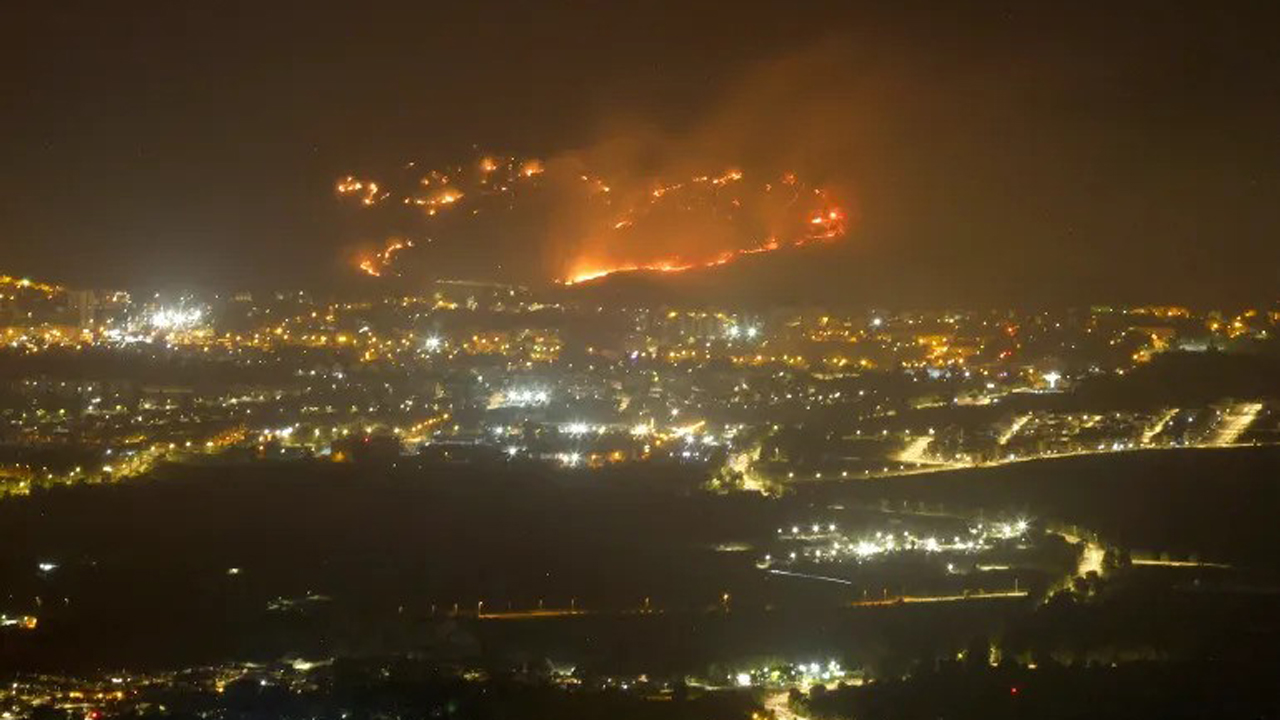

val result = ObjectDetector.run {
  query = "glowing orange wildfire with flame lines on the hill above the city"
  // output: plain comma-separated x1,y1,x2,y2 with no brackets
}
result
337,155,846,284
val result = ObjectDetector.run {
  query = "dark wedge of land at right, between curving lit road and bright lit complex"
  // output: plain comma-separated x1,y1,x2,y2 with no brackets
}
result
803,446,1280,571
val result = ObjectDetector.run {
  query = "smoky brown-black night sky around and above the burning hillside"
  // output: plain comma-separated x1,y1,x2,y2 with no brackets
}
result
0,0,1280,305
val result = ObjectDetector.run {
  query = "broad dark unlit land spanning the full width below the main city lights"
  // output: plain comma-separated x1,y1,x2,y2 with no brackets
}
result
0,448,1280,670
